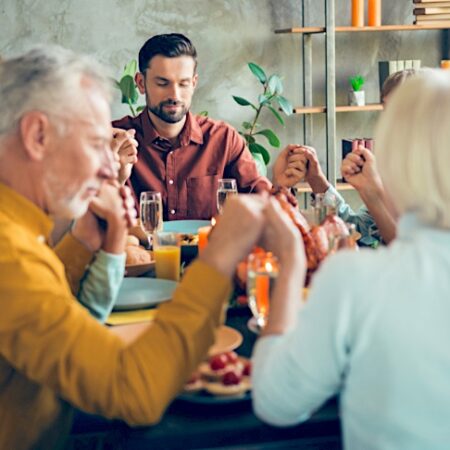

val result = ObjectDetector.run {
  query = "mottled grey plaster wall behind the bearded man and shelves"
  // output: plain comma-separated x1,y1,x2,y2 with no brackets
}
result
0,0,442,207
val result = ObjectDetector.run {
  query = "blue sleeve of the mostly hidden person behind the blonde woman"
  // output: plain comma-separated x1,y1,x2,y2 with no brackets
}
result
325,185,382,247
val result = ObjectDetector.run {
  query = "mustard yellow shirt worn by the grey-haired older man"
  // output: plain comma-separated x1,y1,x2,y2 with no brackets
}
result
0,183,231,450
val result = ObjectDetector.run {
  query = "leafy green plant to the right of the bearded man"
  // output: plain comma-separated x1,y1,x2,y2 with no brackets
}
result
233,63,292,172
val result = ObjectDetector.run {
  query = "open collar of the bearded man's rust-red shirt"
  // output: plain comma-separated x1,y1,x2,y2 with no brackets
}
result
141,108,203,151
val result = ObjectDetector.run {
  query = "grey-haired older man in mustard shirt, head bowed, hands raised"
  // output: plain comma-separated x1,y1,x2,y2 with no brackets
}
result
0,48,263,450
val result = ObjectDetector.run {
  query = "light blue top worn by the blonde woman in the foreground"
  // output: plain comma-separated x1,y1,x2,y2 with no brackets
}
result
253,215,450,450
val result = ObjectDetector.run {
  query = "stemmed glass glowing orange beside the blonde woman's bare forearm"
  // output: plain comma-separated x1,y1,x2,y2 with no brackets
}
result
247,252,279,328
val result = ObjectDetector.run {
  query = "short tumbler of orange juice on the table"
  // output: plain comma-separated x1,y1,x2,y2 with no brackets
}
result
153,231,181,281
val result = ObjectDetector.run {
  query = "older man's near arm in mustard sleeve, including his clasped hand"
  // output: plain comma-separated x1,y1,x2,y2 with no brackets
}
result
0,196,264,425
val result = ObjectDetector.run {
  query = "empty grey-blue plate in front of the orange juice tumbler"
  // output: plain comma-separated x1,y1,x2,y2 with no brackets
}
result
114,278,178,311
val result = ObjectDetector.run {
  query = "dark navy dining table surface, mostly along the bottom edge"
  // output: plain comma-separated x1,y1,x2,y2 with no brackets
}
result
71,306,342,450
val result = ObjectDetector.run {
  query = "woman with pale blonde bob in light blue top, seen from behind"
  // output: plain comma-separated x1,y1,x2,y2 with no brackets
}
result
253,70,450,450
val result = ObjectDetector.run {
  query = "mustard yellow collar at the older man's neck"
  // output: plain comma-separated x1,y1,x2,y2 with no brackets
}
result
0,183,54,242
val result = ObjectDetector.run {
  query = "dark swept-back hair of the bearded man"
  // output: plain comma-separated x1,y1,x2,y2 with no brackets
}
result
139,33,197,73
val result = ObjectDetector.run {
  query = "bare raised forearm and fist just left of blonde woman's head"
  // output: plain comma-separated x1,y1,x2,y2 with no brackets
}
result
341,147,397,243
